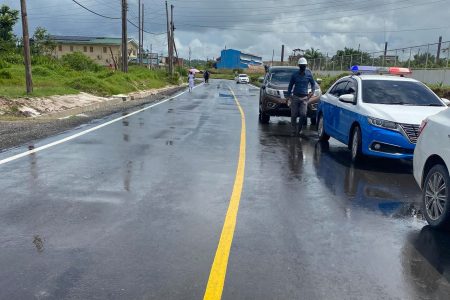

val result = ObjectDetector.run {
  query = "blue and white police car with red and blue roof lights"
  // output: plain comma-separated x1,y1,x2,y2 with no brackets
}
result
317,66,447,162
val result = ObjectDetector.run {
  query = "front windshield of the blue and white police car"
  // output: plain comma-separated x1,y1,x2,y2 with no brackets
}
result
362,80,444,106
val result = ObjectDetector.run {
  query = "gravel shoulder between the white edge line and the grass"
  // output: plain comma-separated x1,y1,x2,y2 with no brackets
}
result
0,87,185,152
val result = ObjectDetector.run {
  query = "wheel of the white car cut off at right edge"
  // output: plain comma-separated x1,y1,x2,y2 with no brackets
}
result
422,164,450,229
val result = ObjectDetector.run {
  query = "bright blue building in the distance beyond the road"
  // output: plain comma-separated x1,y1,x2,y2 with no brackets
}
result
216,49,263,69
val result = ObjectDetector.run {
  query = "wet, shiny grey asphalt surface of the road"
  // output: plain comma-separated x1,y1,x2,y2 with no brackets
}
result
0,80,450,299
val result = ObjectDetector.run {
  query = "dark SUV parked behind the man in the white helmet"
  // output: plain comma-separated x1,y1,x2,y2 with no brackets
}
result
259,67,322,125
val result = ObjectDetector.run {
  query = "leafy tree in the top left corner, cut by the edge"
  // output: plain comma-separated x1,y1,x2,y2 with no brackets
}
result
0,4,19,52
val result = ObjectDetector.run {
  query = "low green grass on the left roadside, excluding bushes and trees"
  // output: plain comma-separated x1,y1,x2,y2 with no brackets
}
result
0,64,170,99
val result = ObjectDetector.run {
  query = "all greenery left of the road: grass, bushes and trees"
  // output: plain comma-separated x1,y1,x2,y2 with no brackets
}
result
0,5,179,99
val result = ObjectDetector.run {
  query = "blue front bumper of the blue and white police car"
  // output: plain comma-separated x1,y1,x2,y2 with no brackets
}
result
362,125,416,160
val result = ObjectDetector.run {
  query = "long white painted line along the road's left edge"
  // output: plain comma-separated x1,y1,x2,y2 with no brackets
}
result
0,83,203,165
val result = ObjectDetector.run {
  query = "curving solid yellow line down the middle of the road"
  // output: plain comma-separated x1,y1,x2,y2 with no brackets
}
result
203,88,246,300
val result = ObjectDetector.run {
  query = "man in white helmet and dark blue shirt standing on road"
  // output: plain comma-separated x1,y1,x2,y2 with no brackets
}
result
288,57,316,136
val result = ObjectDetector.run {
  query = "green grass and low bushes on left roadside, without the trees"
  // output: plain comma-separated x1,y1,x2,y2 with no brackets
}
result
0,52,174,98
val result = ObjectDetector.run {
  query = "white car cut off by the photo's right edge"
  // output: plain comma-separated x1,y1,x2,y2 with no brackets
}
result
413,109,450,228
